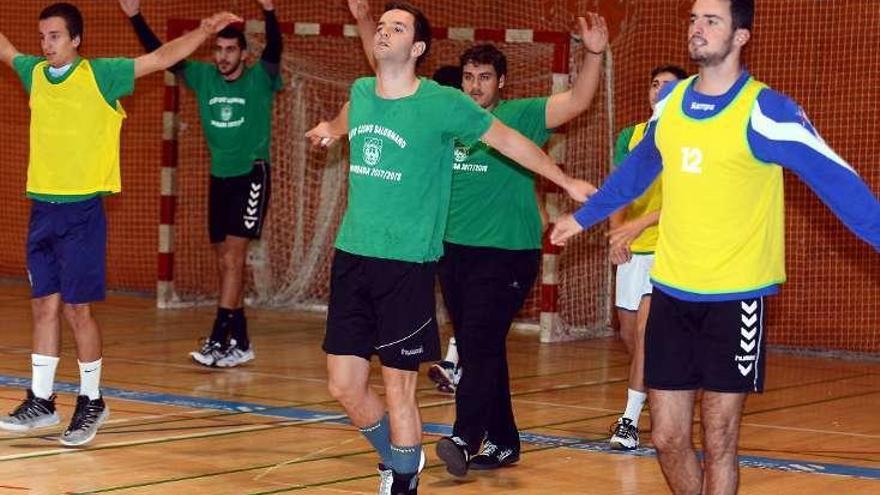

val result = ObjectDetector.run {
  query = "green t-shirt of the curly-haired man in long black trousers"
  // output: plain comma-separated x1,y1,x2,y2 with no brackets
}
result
446,98,551,249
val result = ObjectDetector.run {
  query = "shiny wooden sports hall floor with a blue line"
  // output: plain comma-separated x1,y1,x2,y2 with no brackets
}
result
0,284,880,495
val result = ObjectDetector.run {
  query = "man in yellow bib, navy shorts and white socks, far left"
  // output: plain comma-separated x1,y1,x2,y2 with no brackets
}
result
0,3,239,446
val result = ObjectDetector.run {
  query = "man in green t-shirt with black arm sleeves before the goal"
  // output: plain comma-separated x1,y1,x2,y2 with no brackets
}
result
119,0,283,368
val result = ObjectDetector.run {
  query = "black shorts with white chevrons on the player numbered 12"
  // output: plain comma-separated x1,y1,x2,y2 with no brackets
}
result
645,288,765,392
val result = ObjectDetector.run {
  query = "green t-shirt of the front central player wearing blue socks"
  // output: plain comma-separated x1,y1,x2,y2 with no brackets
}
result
336,77,492,263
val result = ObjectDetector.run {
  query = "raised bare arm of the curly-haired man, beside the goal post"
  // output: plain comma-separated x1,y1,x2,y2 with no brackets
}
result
547,12,608,129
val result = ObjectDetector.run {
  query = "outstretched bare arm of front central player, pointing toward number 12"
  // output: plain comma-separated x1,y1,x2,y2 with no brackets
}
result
482,119,596,202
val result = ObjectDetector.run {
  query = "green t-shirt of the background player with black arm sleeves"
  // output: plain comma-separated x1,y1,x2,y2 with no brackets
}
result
183,61,284,177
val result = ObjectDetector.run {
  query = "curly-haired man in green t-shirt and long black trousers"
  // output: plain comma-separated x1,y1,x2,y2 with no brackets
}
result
349,0,608,476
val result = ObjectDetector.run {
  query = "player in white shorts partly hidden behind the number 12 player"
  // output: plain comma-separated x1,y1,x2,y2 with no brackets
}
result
608,65,687,450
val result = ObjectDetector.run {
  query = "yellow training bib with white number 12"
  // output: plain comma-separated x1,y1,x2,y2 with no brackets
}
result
651,77,785,294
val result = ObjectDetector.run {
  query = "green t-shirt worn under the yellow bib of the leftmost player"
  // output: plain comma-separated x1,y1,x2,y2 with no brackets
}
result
12,54,135,203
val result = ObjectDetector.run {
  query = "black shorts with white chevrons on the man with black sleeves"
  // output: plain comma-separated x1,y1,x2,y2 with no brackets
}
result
208,160,272,244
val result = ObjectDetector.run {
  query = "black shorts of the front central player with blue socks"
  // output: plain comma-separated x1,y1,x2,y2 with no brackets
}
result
323,249,440,371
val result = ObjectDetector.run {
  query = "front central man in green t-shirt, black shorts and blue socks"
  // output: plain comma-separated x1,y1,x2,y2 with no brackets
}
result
307,2,594,495
